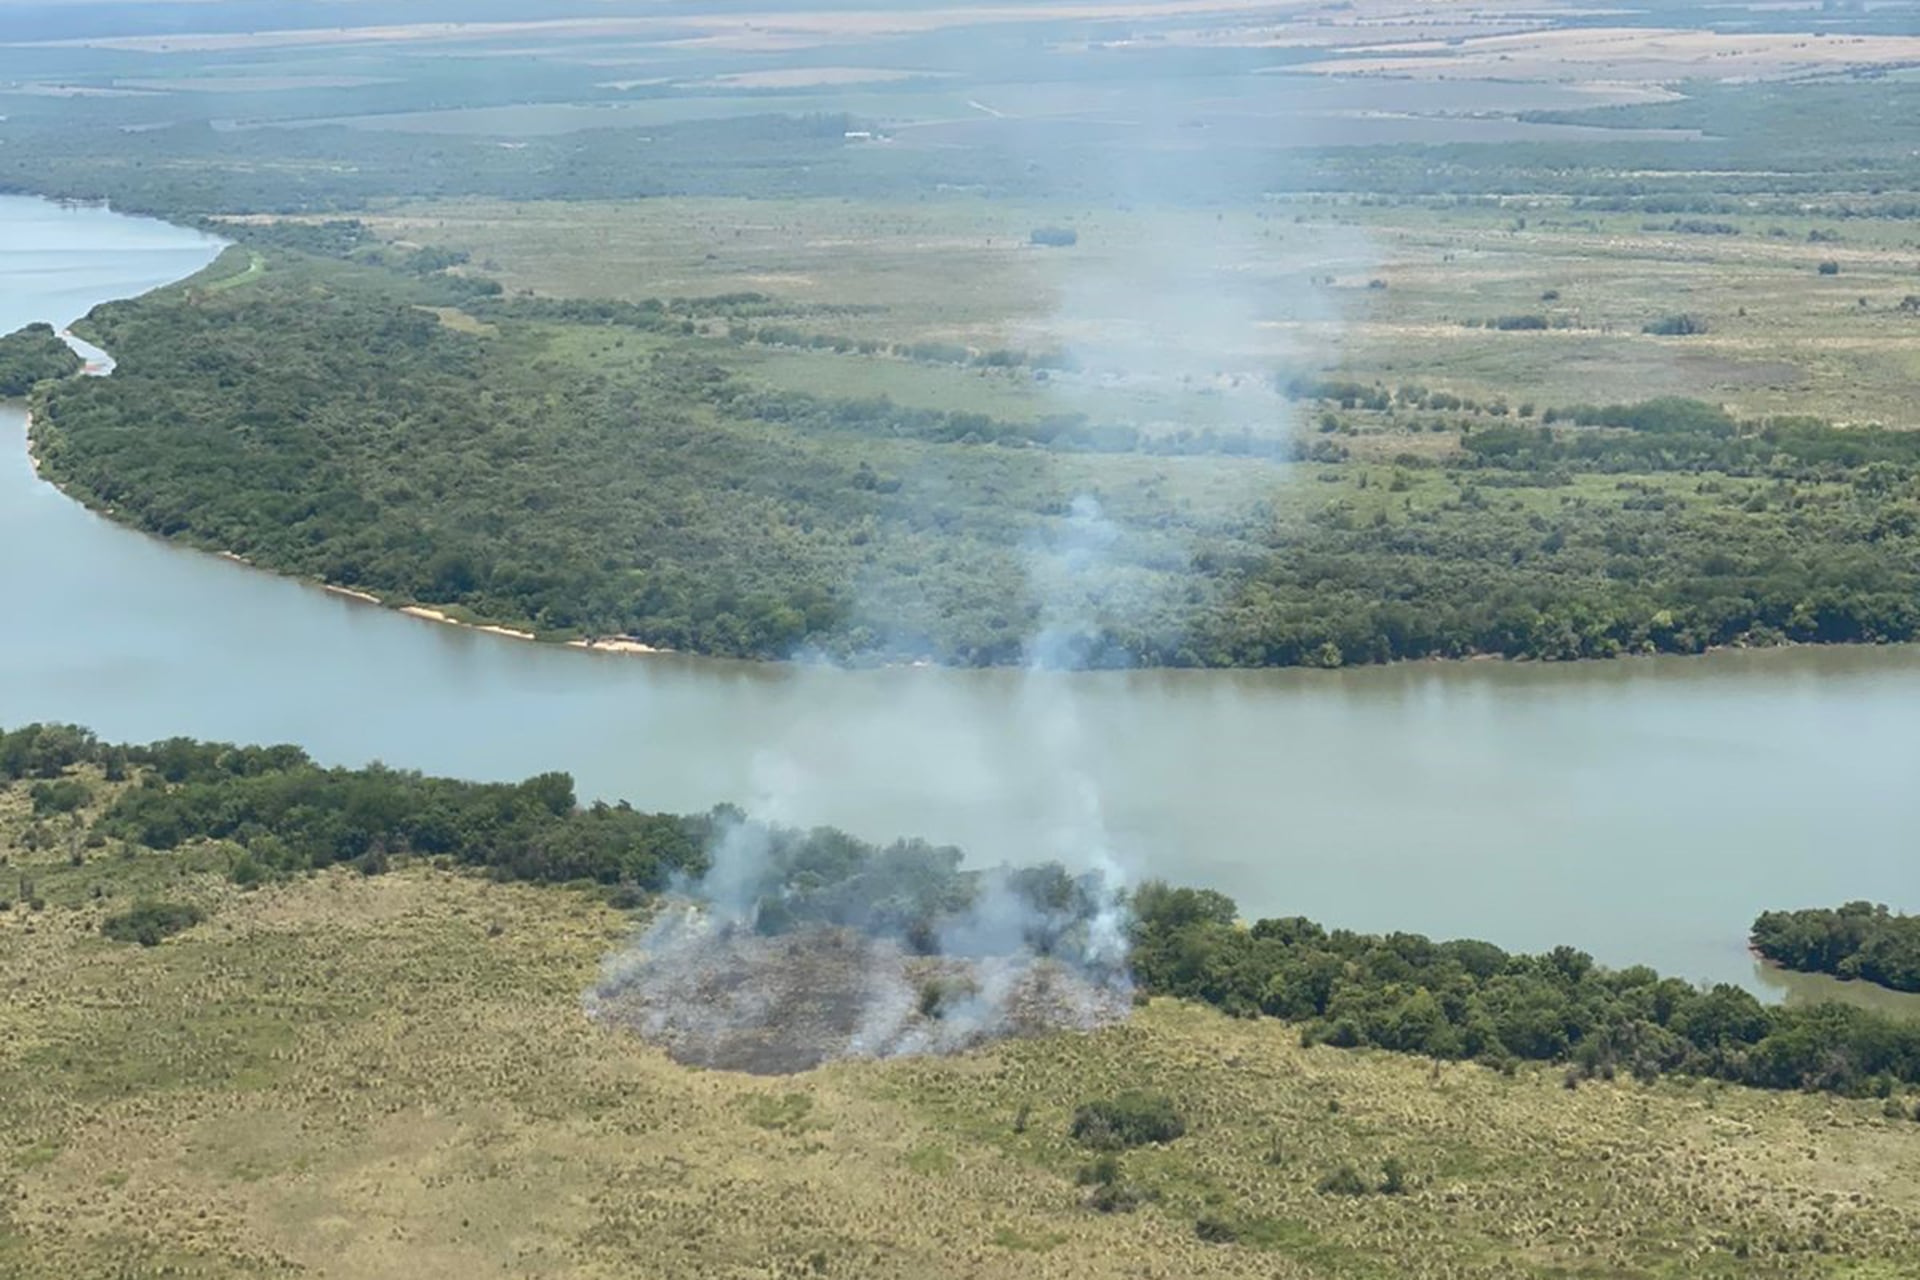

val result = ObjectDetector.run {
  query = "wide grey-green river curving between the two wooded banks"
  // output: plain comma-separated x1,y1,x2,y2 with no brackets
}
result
0,198,1920,1009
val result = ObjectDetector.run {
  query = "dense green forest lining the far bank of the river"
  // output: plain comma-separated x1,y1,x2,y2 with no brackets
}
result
36,247,1920,666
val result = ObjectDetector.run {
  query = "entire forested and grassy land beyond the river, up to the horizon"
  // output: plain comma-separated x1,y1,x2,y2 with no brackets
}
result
0,6,1920,679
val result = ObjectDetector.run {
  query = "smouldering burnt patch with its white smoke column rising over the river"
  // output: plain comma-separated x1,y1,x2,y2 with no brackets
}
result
591,35,1365,1069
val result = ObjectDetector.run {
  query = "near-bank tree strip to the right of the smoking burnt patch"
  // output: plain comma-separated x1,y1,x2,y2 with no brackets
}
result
1133,885,1920,1096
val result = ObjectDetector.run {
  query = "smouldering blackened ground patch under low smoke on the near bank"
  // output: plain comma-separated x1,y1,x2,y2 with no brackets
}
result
588,814,1131,1073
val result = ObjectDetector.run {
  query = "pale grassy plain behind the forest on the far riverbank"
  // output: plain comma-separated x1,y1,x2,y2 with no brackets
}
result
372,198,1920,426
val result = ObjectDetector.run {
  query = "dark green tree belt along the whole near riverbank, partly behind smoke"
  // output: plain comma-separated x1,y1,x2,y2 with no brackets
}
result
11,725,1920,1094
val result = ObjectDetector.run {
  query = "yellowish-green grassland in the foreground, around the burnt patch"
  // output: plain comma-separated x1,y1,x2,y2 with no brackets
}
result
0,775,1920,1278
